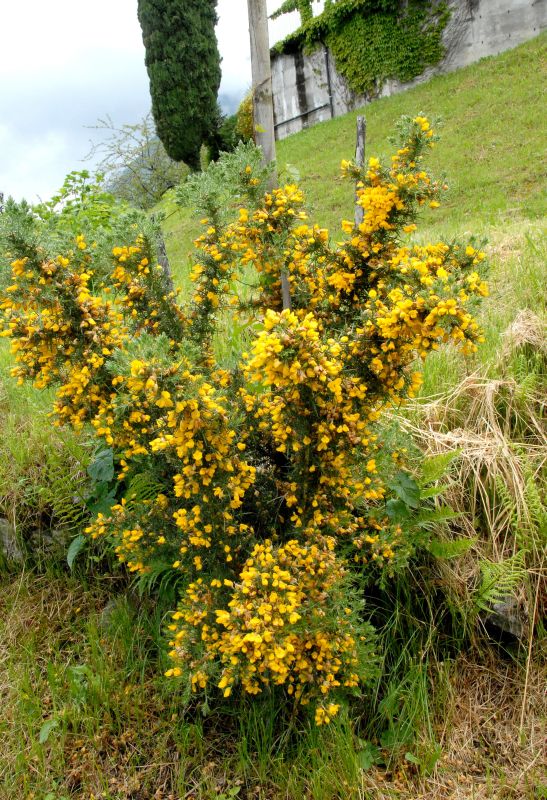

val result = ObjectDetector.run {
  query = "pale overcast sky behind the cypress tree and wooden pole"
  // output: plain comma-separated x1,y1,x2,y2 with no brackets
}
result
0,0,322,202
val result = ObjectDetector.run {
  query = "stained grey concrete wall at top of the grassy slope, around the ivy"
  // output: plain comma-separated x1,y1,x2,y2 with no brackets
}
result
272,0,547,139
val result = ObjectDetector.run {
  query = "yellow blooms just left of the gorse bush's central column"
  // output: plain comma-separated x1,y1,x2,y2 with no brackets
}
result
85,356,255,573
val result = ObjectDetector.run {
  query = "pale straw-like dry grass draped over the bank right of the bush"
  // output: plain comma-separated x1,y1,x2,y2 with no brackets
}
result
403,374,547,556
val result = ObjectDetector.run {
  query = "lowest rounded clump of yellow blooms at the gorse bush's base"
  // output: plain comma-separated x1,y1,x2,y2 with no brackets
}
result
167,532,368,722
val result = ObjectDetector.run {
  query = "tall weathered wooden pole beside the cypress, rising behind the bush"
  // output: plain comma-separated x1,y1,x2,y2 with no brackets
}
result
247,0,291,309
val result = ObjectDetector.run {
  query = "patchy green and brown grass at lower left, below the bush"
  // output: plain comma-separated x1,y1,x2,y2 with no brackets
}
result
0,570,372,800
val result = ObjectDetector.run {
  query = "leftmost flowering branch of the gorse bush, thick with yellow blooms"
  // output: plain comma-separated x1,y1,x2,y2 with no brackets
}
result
0,247,127,428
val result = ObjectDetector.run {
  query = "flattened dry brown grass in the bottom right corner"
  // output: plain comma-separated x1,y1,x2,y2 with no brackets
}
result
362,653,547,800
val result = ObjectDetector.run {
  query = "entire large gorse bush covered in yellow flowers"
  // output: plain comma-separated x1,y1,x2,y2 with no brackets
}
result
1,116,487,724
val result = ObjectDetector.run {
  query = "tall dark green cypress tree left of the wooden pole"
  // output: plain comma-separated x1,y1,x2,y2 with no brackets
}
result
138,0,220,167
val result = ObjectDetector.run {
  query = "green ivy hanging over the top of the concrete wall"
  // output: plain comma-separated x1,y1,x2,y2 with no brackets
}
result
276,0,450,95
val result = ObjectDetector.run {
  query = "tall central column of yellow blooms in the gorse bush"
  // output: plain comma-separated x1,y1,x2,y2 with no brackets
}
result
242,310,383,531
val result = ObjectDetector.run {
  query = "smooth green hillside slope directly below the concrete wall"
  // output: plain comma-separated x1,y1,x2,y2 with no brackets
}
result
163,34,547,288
